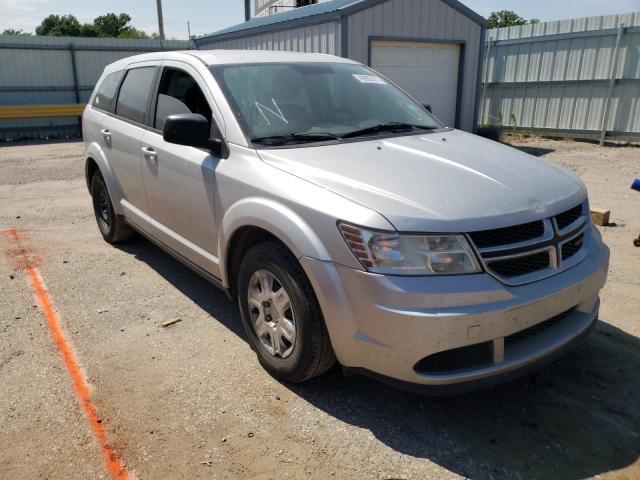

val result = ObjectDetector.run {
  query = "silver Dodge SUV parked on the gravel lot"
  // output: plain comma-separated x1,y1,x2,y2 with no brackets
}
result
83,50,609,393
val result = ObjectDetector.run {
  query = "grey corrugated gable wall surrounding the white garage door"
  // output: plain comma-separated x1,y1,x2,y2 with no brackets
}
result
348,0,482,131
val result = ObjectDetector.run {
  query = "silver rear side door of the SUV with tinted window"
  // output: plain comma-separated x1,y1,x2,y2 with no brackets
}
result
101,64,158,216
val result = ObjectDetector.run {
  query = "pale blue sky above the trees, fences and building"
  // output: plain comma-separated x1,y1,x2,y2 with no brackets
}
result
0,0,640,39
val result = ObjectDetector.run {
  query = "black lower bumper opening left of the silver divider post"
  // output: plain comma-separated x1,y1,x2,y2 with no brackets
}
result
413,342,493,373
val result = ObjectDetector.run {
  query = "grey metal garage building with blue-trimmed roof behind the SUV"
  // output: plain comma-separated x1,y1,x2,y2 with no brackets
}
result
196,0,486,131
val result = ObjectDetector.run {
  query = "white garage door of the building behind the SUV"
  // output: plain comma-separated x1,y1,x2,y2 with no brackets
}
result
371,40,460,126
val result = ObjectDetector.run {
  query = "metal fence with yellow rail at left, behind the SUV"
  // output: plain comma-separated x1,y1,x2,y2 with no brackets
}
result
0,36,194,140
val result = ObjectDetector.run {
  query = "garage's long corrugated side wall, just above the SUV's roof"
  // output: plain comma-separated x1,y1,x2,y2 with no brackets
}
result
200,22,340,55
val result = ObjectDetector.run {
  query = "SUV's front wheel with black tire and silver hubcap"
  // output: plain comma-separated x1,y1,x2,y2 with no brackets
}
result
237,241,336,383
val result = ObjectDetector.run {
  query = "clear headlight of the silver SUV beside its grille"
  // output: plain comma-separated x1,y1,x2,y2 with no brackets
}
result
338,223,481,275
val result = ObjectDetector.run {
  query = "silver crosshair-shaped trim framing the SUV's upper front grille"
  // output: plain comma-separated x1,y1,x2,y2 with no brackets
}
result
467,202,590,286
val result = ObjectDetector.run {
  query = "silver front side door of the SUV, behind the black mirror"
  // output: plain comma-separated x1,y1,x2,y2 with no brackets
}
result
141,61,221,276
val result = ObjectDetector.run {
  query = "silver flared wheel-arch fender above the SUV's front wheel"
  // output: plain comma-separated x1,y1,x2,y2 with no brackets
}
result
218,197,331,285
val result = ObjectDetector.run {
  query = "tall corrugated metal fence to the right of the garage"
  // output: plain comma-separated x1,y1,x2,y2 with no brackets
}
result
480,12,640,139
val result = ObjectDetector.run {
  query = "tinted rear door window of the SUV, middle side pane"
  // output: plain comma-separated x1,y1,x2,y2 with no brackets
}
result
116,67,156,123
